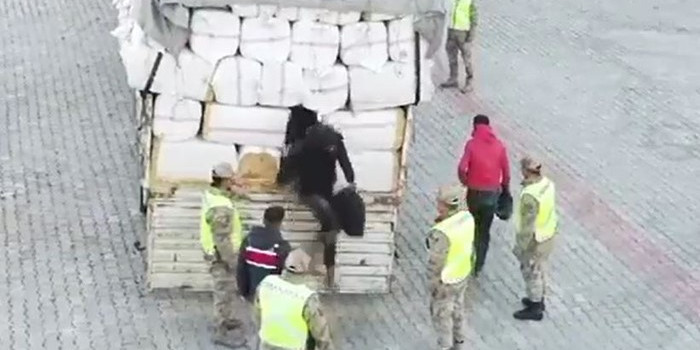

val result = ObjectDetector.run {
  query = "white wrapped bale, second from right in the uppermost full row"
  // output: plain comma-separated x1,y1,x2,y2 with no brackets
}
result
340,22,389,70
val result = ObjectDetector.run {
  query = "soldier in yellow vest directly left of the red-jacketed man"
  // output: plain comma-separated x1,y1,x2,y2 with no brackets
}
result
426,186,475,350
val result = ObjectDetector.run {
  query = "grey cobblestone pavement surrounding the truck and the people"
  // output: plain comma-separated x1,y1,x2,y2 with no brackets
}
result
0,0,700,350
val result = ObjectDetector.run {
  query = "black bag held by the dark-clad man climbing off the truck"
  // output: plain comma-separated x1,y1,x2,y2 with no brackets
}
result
330,187,366,237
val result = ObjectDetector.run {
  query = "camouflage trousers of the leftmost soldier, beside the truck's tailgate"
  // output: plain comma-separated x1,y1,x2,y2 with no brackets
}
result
209,262,248,333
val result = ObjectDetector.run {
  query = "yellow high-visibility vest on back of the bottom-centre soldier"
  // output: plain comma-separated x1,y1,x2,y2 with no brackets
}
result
258,275,314,350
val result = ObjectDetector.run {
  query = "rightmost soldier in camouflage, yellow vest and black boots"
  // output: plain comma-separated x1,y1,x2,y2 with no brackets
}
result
513,157,557,321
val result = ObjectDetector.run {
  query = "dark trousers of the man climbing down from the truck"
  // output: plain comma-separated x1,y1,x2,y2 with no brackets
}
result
301,194,340,266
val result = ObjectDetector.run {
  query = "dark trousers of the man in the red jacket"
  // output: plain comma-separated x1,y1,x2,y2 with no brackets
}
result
467,190,500,273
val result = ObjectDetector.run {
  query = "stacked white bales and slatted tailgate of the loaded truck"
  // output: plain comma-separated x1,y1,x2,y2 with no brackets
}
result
115,0,433,293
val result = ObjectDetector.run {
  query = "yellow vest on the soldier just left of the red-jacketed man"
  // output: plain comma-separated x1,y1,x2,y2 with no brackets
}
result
433,210,474,284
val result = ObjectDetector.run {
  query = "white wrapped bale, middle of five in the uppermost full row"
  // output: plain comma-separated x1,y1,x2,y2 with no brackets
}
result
290,21,340,70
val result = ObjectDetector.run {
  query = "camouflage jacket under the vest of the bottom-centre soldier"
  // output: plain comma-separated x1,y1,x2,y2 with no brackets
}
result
254,271,335,350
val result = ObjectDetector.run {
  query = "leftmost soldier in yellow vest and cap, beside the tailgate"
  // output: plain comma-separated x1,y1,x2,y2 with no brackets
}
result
200,163,246,348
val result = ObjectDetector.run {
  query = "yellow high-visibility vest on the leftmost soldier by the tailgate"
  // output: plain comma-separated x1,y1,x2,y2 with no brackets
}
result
199,190,243,255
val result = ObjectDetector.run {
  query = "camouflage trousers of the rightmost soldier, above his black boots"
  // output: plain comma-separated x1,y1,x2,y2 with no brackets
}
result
519,238,554,302
